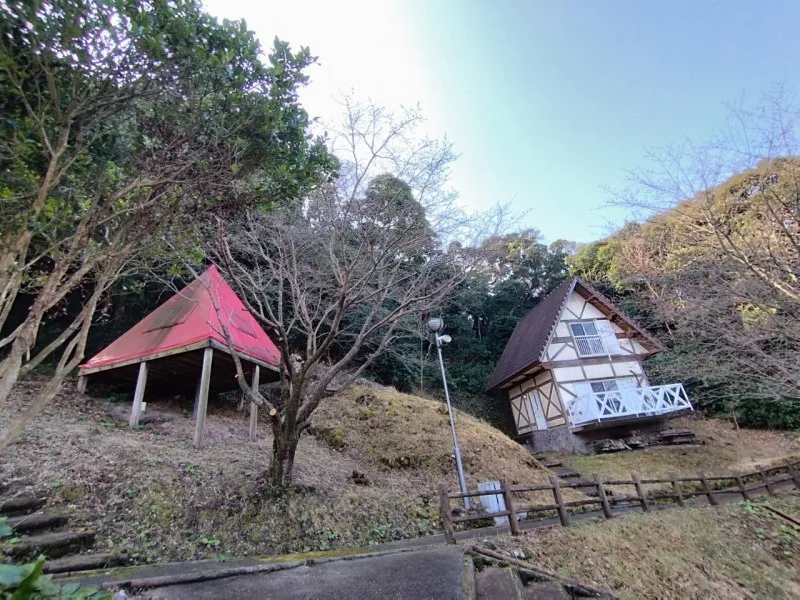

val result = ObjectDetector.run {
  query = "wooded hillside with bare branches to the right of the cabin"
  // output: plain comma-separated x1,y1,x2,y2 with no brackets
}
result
570,98,800,428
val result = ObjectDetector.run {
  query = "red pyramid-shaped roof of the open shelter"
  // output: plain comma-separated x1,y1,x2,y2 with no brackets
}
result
80,266,280,369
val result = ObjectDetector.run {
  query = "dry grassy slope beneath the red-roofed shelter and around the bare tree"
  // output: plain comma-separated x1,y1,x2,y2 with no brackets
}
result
0,382,545,561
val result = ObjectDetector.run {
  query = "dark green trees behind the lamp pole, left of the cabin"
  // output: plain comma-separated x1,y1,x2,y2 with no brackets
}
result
371,230,572,433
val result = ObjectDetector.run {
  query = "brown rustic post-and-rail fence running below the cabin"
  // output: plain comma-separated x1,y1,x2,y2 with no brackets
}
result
439,459,800,544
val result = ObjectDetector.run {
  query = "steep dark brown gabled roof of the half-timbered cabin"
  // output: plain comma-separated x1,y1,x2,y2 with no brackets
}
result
486,277,664,391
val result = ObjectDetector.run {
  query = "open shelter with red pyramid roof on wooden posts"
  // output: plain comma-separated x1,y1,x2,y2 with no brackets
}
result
78,266,280,446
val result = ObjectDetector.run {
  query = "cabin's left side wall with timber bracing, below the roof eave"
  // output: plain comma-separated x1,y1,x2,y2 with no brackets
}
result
508,370,567,435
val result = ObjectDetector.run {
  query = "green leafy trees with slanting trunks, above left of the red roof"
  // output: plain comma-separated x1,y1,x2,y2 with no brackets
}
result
0,0,335,448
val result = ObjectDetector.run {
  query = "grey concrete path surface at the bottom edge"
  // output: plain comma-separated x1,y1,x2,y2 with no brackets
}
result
146,546,473,600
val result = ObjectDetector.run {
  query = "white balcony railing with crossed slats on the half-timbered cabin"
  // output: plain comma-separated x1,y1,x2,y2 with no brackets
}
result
566,383,693,427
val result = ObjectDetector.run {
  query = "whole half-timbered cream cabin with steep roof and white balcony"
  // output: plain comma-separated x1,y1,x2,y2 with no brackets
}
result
487,277,692,452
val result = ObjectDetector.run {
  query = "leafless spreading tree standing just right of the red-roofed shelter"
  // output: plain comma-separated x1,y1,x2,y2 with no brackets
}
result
209,104,494,486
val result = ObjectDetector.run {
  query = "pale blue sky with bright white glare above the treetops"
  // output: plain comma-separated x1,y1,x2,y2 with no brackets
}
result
207,0,800,242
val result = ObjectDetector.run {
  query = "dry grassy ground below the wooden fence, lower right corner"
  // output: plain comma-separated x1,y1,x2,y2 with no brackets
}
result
482,493,800,600
